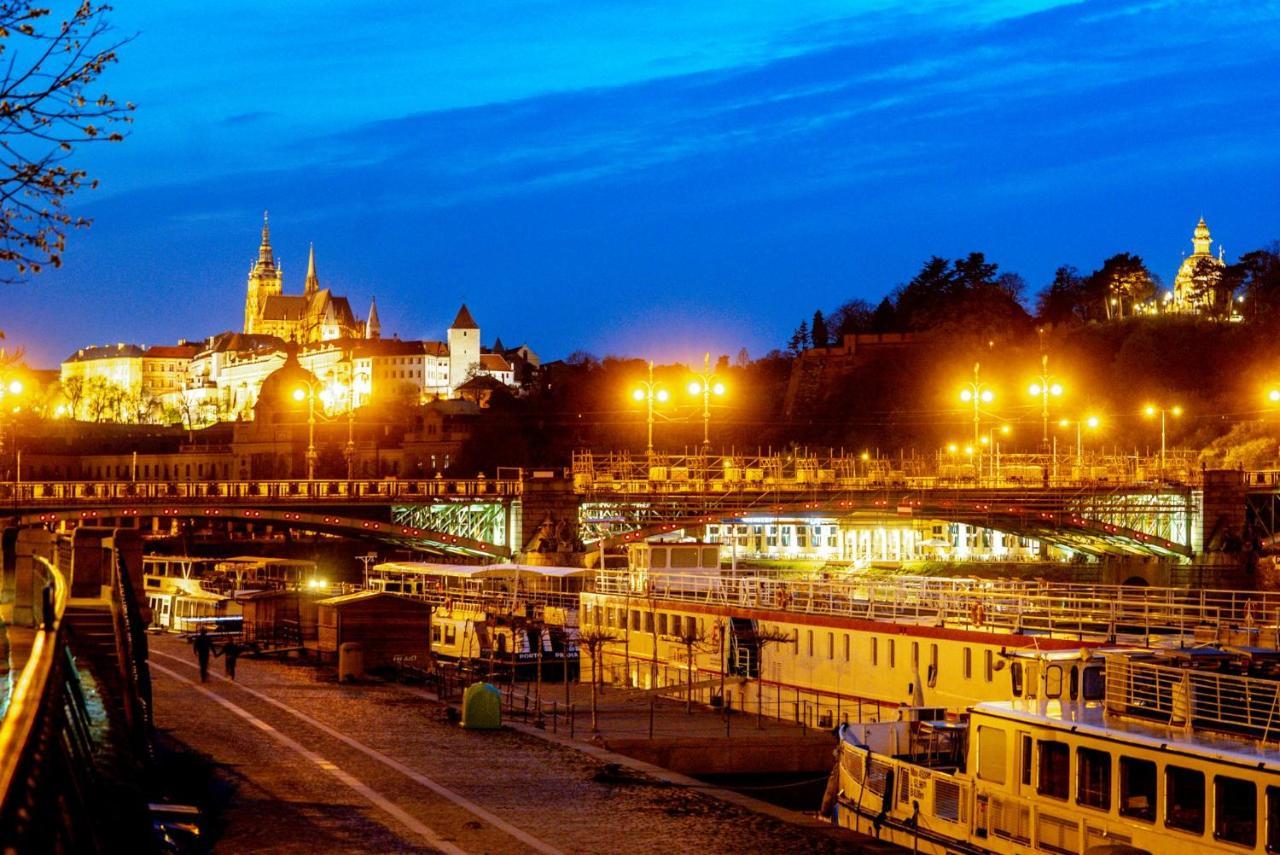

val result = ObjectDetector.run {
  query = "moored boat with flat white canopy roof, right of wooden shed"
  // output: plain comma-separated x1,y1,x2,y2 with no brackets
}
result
367,562,590,680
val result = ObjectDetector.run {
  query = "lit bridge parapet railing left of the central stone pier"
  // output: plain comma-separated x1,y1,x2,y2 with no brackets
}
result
0,477,521,507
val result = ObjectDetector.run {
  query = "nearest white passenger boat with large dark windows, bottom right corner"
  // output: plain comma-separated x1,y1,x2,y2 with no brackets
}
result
833,649,1280,855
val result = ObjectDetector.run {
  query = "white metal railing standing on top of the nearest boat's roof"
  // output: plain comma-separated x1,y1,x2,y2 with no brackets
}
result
1106,654,1280,742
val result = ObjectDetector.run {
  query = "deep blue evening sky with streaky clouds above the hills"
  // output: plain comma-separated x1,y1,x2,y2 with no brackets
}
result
0,0,1280,366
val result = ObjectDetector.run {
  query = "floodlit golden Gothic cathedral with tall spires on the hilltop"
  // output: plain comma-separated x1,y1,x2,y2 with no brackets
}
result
244,214,380,344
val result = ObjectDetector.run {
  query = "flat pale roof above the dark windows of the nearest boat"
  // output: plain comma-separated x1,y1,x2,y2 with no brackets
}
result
972,700,1280,774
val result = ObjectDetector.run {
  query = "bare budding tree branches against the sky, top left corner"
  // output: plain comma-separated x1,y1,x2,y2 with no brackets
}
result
0,0,133,282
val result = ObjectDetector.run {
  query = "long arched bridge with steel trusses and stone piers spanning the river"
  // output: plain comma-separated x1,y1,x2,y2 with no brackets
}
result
0,452,1264,559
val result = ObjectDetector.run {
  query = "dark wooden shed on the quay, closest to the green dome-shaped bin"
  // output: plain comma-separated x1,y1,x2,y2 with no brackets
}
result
316,591,431,669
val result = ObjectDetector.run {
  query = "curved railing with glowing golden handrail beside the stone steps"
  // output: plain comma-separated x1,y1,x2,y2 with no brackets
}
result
0,558,100,852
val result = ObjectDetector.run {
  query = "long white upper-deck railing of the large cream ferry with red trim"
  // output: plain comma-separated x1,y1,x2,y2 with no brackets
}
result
595,570,1280,648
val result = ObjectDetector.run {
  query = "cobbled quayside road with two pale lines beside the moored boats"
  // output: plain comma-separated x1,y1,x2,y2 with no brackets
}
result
151,636,901,855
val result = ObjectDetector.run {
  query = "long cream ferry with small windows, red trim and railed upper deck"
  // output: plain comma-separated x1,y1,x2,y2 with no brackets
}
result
581,543,1280,727
